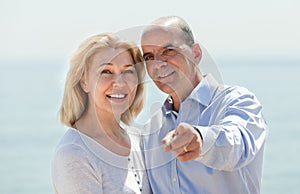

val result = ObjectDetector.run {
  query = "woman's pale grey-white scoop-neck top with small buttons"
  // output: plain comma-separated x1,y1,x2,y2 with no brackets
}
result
52,127,151,194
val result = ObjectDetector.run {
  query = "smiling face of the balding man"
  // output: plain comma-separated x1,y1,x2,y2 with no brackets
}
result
142,27,195,96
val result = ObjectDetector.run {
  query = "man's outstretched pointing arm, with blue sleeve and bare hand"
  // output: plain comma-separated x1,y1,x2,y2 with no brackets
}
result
162,88,267,170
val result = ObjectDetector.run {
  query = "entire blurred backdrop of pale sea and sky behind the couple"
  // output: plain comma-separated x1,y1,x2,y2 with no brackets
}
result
0,0,300,194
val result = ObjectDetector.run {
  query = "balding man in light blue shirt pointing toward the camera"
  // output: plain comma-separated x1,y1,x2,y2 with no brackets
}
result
141,16,267,194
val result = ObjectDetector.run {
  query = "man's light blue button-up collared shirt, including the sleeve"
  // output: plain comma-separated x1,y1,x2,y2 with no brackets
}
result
142,75,267,194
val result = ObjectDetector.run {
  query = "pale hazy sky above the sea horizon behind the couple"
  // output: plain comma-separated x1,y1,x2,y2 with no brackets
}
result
0,0,300,62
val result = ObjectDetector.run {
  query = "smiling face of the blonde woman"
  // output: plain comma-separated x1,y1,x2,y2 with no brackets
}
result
84,48,138,117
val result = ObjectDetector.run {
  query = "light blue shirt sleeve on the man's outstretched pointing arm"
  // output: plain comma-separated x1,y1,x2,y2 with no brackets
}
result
196,87,267,171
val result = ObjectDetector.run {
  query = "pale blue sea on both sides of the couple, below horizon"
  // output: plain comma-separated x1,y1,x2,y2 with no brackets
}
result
0,56,300,194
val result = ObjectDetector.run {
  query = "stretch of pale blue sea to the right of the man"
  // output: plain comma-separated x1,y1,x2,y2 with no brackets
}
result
217,60,300,194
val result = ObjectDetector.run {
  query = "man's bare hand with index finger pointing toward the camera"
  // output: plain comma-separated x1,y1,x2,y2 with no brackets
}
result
162,123,202,162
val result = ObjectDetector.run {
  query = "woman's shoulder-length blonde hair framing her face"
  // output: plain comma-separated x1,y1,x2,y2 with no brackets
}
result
59,33,145,127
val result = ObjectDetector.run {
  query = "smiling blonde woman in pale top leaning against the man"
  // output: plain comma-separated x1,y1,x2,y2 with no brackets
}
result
52,34,151,194
